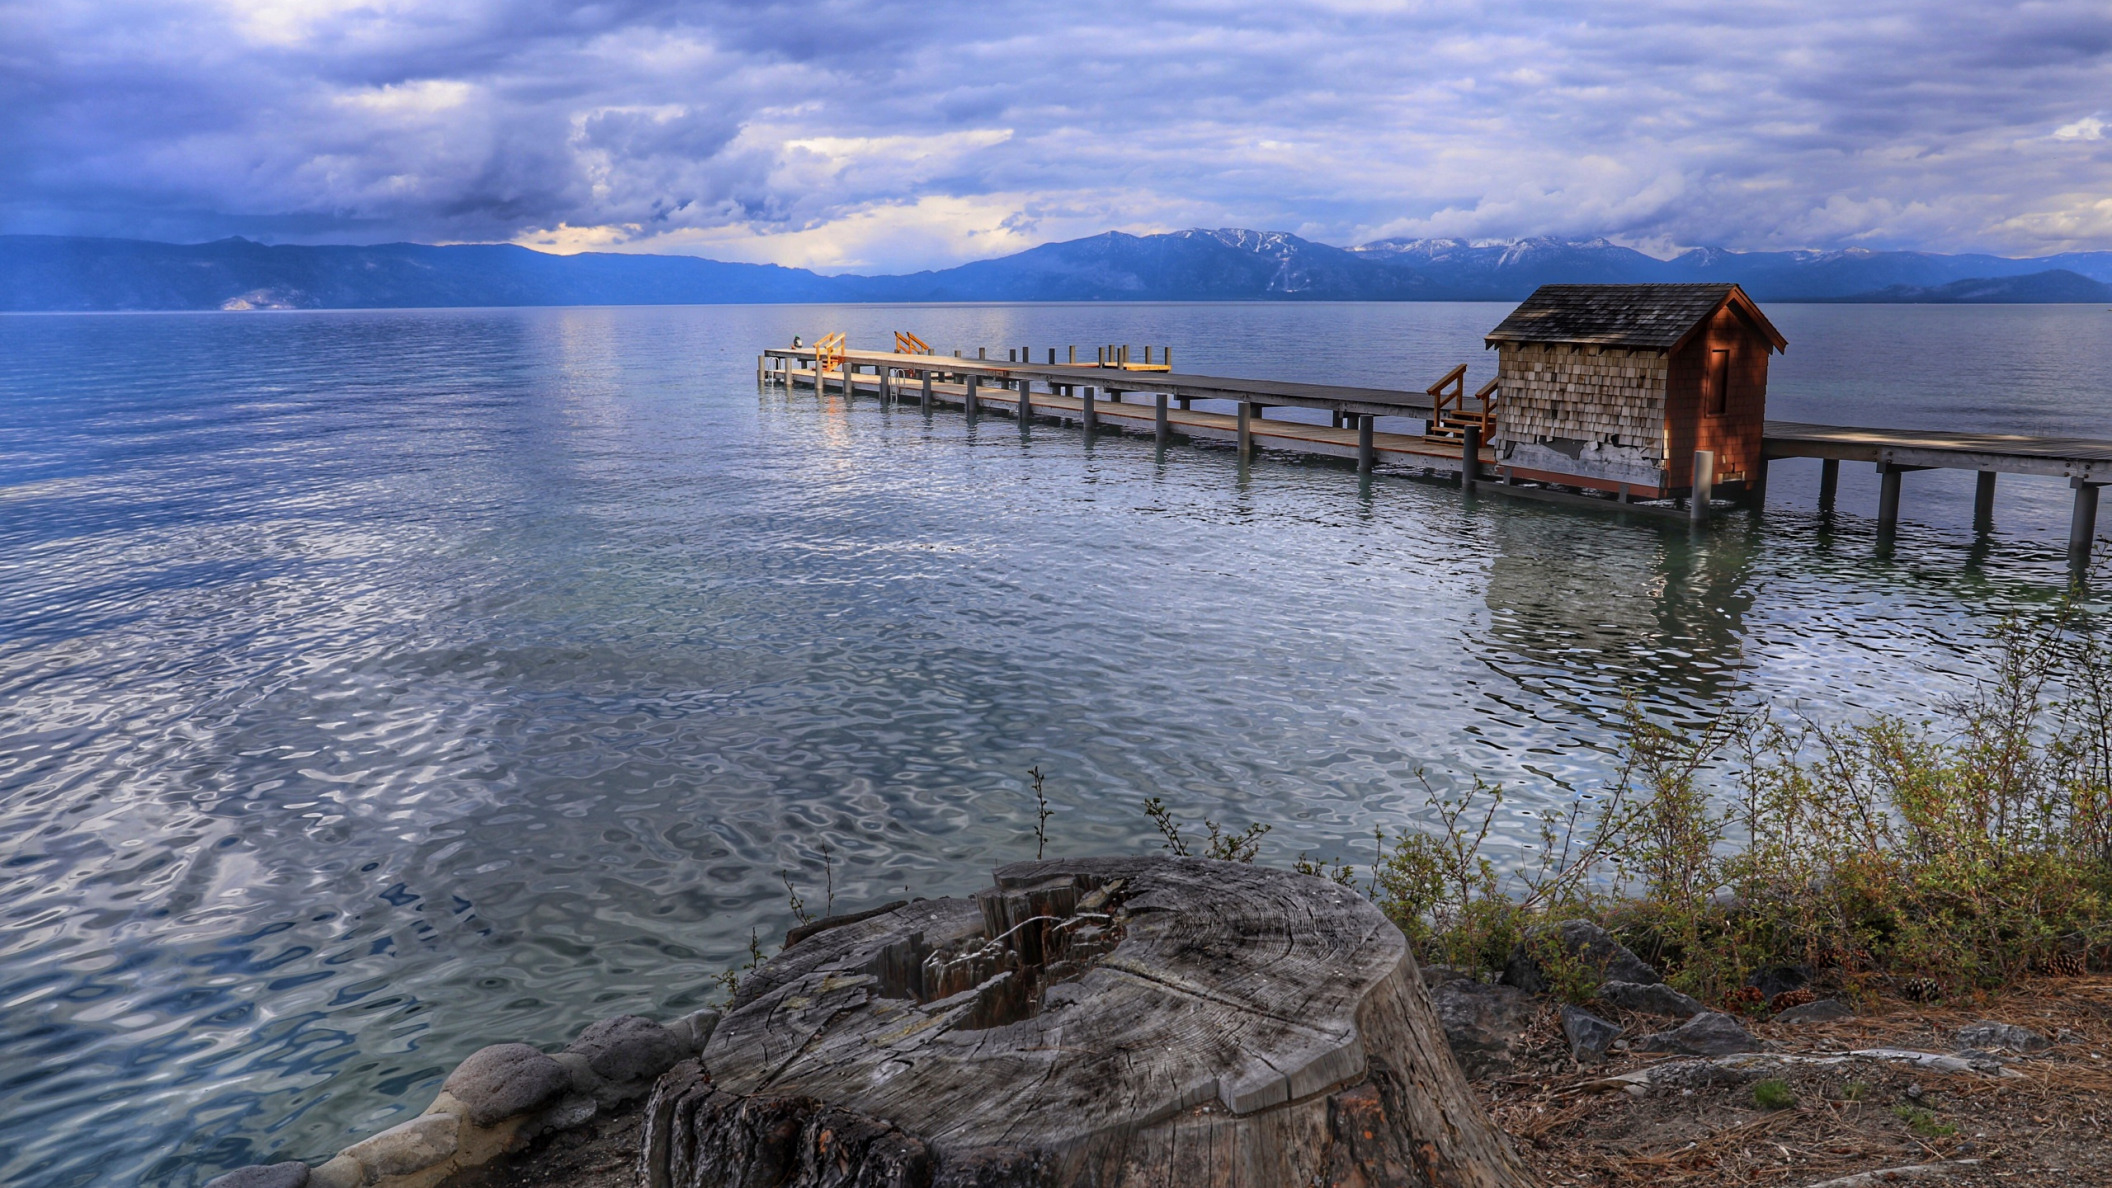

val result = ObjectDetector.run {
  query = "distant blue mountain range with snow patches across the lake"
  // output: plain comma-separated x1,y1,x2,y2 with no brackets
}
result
0,230,2112,311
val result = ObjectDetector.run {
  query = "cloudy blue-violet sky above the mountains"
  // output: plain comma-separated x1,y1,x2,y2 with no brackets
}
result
0,0,2112,273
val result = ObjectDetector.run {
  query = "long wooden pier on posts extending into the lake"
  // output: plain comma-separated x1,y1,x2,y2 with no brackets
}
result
756,347,2112,569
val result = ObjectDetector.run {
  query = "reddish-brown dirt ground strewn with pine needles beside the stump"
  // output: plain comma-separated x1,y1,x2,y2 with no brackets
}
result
448,977,2112,1188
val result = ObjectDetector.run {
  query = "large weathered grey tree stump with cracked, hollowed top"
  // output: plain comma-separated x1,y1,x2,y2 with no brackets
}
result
644,858,1533,1188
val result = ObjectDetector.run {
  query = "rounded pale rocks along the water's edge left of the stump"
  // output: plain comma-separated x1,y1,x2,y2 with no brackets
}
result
205,1010,718,1188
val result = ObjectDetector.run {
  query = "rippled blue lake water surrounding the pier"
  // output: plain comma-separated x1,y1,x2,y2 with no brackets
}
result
0,304,2112,1186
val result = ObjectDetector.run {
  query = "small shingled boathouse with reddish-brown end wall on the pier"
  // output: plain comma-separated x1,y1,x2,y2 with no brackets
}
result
1485,283,1789,499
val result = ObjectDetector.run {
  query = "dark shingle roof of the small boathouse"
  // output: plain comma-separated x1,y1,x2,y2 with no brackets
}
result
1487,283,1787,351
